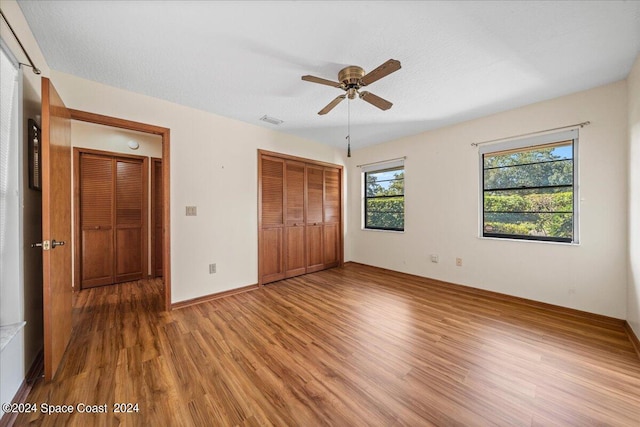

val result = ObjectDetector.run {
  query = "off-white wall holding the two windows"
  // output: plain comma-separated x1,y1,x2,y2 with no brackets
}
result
348,81,628,318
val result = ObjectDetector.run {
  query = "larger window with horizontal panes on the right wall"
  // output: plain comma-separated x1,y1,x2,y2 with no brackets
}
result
480,130,578,243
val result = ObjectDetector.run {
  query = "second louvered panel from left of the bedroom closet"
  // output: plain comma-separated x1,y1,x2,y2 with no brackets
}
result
285,161,307,277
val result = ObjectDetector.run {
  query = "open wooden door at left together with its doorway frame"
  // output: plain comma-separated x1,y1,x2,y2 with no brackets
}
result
33,77,171,381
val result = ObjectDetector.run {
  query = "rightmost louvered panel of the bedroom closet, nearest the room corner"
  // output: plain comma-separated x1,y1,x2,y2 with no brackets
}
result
323,168,342,268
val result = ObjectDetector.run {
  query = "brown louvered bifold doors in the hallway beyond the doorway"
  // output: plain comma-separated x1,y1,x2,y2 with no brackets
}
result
74,148,148,289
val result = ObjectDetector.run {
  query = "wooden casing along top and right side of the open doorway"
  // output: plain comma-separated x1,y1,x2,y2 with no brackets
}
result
69,109,171,311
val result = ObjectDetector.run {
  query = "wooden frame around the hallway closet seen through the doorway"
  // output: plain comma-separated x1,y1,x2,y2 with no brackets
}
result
73,147,149,292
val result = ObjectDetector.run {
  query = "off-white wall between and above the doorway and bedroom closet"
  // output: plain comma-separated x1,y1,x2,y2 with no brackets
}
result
51,71,344,302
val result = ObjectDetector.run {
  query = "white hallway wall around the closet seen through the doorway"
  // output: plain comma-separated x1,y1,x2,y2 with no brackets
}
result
71,120,162,283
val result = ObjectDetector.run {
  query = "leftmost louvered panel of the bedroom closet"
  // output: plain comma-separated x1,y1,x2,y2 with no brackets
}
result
259,156,285,284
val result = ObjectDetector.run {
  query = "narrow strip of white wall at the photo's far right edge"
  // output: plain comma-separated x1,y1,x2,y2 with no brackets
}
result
627,55,640,337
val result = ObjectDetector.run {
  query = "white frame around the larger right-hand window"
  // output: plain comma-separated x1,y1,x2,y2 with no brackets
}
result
478,129,580,245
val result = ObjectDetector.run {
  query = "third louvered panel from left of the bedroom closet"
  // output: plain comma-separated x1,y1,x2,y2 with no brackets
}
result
306,165,324,273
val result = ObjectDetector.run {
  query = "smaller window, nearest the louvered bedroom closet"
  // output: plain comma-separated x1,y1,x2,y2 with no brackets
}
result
363,161,404,231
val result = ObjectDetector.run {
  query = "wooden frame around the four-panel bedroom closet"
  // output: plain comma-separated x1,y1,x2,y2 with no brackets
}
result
257,149,344,286
